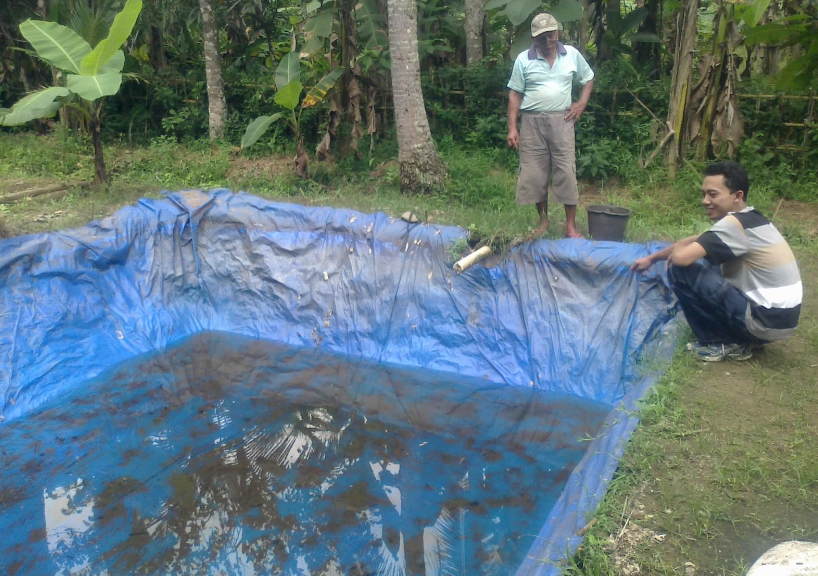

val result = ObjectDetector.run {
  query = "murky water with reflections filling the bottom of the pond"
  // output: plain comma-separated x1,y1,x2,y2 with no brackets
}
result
0,333,610,576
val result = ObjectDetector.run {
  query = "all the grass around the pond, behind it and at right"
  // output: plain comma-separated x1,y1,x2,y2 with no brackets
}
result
0,134,818,576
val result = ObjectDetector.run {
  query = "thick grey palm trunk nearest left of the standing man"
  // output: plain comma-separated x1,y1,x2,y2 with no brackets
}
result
387,0,447,193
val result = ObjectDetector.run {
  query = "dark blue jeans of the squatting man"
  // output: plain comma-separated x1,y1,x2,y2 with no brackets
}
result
667,260,767,344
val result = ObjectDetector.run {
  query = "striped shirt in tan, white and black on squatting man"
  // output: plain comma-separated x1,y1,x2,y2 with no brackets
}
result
696,206,803,340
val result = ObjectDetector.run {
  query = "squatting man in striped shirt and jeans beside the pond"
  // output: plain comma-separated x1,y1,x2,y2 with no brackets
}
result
631,162,803,362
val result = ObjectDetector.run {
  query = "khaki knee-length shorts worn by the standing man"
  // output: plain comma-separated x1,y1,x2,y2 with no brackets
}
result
517,112,579,205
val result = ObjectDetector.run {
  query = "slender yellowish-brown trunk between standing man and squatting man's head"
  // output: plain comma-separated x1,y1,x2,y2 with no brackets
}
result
665,0,699,177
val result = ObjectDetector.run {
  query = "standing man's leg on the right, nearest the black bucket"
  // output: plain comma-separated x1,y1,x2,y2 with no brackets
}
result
547,114,582,238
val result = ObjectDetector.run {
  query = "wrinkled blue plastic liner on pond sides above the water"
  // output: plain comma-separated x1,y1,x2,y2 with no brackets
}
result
0,190,678,575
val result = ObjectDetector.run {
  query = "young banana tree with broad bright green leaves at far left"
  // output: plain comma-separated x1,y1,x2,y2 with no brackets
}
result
0,0,142,184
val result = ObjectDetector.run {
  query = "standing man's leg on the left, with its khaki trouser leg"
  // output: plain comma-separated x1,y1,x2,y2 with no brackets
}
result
517,114,551,236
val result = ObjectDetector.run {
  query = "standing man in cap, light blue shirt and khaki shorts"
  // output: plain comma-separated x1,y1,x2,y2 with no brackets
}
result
507,14,594,238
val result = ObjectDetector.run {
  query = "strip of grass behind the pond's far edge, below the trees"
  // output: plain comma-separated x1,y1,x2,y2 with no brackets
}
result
0,133,756,248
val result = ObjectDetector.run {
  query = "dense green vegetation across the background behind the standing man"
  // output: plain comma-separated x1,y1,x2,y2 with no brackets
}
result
0,0,818,198
